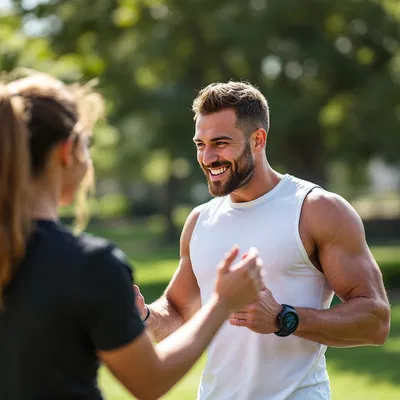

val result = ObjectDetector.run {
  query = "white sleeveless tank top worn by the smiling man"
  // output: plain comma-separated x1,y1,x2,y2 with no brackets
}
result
190,175,333,400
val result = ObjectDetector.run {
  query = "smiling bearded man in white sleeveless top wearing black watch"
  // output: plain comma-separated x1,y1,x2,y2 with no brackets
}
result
135,82,390,400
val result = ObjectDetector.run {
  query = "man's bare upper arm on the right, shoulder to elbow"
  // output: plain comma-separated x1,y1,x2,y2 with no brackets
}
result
314,194,384,300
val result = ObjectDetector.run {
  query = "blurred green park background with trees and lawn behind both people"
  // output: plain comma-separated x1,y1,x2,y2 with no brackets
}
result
0,0,400,400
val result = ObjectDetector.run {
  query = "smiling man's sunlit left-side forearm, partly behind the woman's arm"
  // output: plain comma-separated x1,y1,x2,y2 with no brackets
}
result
147,296,184,342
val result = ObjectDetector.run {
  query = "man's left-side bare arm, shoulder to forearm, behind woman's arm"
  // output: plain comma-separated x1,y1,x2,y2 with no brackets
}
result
148,209,201,341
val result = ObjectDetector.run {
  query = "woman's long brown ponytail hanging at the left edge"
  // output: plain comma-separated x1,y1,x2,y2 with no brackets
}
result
0,85,31,308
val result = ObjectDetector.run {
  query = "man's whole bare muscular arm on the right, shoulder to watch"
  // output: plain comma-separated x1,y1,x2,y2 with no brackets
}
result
295,190,390,347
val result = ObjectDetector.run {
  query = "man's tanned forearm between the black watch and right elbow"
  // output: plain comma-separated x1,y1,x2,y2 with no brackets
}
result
294,298,390,347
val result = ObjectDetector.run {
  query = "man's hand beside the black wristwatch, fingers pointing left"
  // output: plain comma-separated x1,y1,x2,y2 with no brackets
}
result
229,286,282,334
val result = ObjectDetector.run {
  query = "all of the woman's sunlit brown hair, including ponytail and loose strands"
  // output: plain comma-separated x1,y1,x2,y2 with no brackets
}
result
0,71,103,304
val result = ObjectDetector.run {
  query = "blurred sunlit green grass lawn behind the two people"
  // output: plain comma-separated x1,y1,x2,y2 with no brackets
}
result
86,222,400,400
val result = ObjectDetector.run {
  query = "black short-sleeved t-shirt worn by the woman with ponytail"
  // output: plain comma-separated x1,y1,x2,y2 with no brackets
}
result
0,221,144,400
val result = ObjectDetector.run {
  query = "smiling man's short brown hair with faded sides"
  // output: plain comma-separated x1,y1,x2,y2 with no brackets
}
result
192,81,269,135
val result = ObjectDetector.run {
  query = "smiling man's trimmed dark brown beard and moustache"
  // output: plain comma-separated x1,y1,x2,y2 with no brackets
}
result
202,142,254,197
